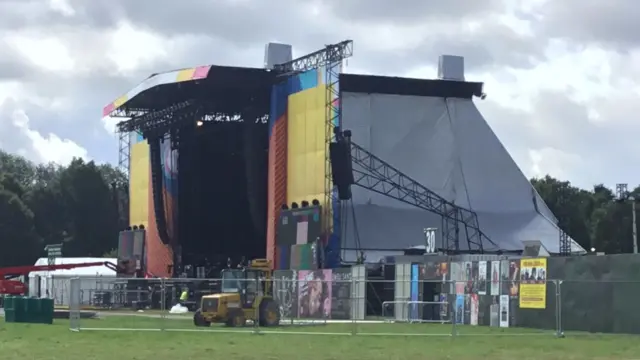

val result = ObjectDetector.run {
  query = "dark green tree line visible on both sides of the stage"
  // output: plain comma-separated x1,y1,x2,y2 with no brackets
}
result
0,151,640,267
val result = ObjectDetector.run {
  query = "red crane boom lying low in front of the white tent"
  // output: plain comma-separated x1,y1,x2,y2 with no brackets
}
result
0,261,121,295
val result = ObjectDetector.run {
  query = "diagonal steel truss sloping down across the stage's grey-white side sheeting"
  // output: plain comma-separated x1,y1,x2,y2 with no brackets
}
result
351,142,499,253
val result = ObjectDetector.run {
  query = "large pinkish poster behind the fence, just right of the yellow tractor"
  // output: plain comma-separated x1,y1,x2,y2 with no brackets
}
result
298,270,332,319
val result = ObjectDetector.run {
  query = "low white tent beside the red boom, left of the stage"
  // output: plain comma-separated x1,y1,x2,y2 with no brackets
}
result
29,257,117,306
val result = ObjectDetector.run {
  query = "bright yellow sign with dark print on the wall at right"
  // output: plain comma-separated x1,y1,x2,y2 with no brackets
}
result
520,258,547,309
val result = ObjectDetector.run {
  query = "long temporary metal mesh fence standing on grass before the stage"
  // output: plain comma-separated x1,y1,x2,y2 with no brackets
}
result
61,276,580,337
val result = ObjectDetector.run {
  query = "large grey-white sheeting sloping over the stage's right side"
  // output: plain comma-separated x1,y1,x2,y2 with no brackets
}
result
341,57,584,261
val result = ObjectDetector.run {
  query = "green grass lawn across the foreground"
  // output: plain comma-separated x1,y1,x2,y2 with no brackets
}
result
0,315,640,360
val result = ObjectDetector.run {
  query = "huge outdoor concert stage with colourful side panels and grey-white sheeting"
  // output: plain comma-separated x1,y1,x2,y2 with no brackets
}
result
103,42,583,276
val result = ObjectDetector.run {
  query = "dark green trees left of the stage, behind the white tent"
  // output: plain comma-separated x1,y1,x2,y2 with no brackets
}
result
0,151,128,267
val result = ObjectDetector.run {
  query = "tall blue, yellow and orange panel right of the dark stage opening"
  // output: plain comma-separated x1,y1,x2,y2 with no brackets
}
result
267,65,341,268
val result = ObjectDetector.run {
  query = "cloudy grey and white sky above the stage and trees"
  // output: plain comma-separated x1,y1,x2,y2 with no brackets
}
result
0,0,640,187
